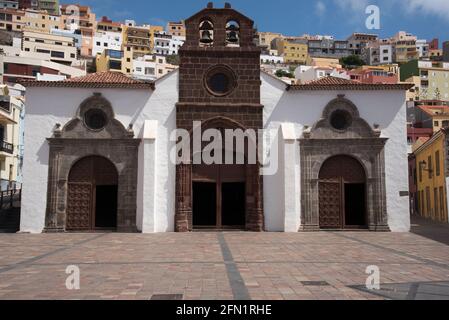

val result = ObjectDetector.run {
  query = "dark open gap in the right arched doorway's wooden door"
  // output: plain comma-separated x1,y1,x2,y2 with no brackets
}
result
345,183,366,227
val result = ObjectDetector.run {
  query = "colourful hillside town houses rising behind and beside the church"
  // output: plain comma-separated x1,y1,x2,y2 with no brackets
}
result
0,0,449,232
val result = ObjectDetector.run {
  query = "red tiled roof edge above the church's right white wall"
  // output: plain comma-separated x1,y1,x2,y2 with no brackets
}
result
287,76,413,90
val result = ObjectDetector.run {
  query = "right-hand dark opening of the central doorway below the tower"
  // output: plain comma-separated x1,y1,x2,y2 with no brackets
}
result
221,182,246,228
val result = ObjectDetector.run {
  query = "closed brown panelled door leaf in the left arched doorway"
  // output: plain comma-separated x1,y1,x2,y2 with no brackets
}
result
66,182,93,231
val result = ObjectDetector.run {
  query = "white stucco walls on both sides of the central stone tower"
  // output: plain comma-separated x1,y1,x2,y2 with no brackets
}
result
21,72,410,233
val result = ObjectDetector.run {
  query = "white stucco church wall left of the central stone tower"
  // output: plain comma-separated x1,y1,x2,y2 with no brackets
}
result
21,72,178,233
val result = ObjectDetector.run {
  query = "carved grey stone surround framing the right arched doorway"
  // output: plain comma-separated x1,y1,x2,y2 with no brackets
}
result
299,95,389,231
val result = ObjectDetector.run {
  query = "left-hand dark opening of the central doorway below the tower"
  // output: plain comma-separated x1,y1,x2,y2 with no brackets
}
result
193,182,217,228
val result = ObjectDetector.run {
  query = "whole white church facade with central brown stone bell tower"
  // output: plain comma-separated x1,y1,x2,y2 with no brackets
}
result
21,4,410,233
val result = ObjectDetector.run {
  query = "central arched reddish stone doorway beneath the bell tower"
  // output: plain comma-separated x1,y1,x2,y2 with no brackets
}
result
175,117,264,232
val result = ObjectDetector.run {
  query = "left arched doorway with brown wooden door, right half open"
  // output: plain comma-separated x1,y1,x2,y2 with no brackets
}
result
66,156,118,231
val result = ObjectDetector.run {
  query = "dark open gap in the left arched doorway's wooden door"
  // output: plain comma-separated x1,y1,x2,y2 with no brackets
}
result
95,186,118,229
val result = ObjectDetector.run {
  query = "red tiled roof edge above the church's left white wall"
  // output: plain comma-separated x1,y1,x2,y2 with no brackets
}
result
21,72,154,90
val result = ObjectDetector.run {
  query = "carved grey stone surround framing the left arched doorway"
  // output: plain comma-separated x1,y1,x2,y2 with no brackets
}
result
45,94,140,232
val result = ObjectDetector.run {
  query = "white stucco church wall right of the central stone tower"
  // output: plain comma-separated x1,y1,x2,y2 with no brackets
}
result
261,74,410,232
